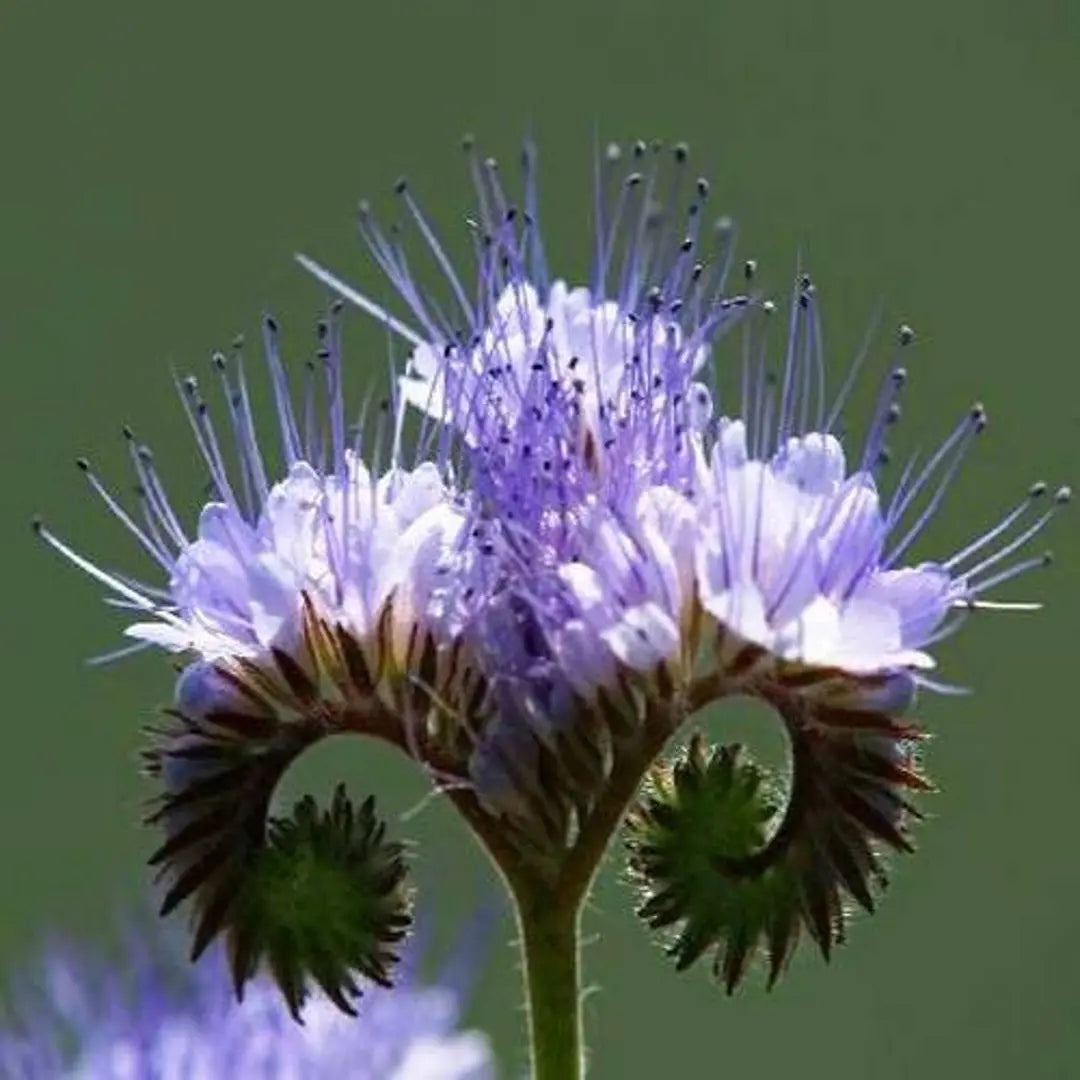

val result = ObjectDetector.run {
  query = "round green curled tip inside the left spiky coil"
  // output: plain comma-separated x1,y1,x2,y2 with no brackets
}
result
227,785,411,1018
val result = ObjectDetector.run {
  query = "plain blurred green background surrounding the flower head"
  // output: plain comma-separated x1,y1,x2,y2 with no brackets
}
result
0,0,1080,1080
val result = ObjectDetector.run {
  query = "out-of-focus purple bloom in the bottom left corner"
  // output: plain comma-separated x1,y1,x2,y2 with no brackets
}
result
0,928,494,1080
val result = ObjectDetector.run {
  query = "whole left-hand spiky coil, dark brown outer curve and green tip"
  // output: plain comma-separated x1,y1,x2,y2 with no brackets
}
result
146,672,409,1015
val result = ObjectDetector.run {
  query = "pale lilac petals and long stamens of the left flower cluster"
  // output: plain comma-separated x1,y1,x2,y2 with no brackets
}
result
42,316,463,667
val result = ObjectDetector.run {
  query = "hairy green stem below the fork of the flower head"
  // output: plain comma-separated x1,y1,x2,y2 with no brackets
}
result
516,890,584,1080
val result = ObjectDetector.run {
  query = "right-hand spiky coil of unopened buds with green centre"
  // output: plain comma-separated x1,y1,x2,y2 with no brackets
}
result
627,713,929,994
